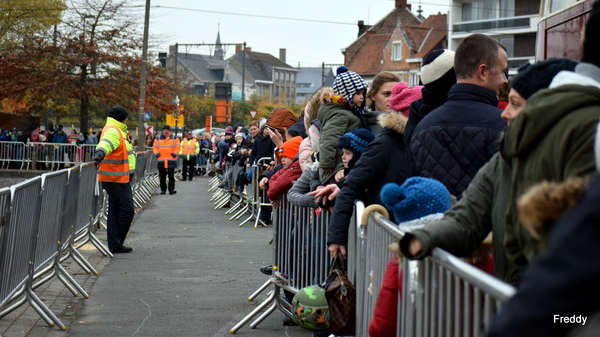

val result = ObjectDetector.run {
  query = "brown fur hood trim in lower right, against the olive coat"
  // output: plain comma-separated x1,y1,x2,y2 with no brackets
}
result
517,178,589,244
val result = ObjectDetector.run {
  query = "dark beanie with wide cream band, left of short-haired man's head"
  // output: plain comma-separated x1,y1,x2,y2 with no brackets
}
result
421,49,456,94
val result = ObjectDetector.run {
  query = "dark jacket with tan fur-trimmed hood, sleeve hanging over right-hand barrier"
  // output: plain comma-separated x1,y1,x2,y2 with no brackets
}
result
327,113,410,246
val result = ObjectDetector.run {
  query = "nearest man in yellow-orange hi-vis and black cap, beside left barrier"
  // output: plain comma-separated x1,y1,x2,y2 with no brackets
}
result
92,106,136,254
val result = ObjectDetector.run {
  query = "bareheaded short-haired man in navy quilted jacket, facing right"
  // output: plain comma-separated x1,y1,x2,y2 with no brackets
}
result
409,34,508,198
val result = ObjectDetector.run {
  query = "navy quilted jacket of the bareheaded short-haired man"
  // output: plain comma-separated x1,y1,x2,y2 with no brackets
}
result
409,83,506,198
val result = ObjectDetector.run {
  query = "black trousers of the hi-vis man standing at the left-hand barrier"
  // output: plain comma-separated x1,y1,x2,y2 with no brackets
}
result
102,181,135,250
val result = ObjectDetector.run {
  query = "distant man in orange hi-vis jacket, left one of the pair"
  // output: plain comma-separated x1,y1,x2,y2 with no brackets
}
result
152,125,180,194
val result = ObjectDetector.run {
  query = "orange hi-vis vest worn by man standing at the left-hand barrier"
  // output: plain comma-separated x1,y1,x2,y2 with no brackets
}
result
98,124,130,184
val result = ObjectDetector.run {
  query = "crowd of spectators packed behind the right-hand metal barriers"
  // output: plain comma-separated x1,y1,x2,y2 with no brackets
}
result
207,3,600,336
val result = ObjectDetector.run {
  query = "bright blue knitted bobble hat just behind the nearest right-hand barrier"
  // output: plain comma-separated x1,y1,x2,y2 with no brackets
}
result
380,177,452,223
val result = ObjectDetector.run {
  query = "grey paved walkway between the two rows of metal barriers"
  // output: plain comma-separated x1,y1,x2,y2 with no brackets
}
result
0,178,311,337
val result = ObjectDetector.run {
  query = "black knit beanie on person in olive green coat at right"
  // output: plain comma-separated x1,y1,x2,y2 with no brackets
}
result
510,57,577,99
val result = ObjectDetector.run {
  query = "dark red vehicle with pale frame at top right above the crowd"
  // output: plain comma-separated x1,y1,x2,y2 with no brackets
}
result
535,0,596,61
